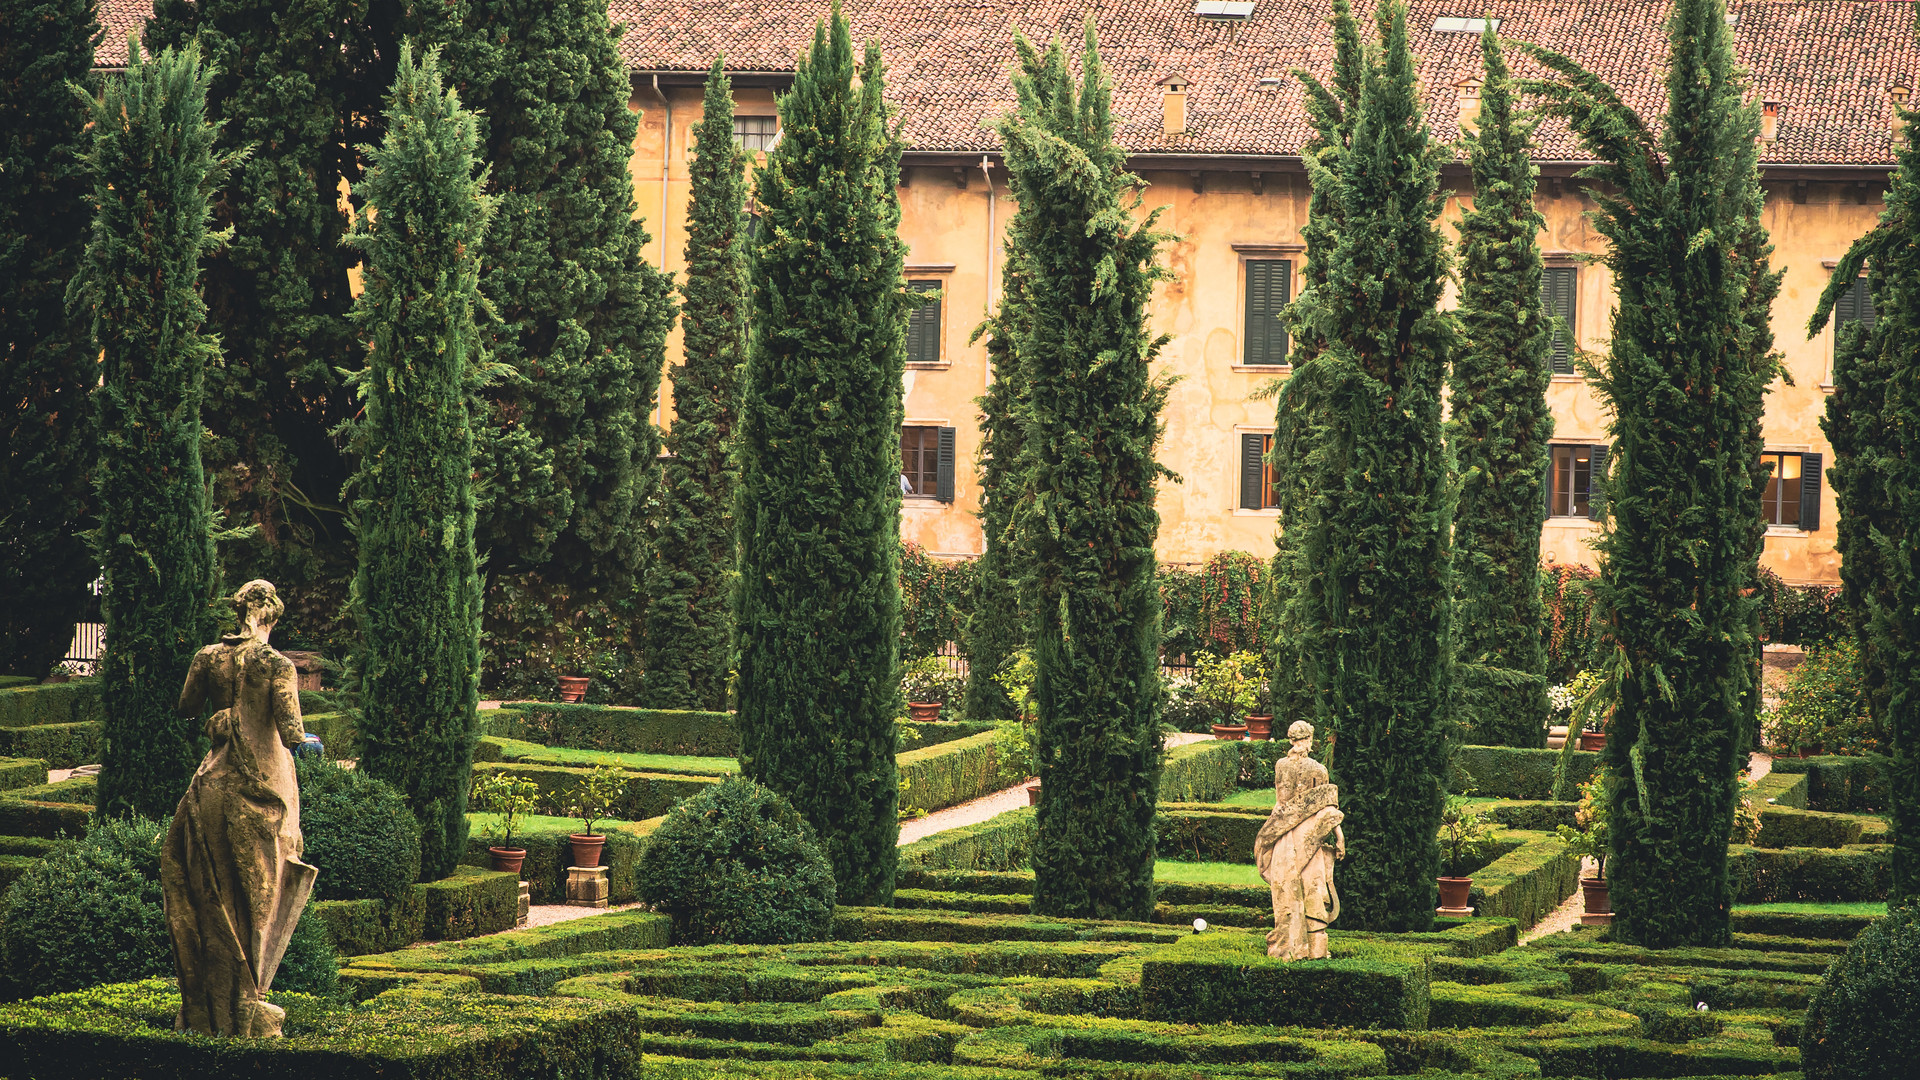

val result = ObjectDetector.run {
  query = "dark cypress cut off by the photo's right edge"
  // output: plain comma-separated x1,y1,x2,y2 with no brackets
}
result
1807,88,1920,903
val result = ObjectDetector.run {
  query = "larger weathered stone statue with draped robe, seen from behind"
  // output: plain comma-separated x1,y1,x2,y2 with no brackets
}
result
159,580,319,1038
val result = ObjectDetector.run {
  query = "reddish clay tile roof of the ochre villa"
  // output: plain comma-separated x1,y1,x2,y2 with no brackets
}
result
100,0,1920,167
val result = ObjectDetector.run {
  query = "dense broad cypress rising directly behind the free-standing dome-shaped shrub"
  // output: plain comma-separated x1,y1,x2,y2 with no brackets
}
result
733,4,914,903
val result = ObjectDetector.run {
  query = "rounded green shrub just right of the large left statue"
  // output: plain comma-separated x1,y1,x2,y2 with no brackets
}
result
298,757,420,899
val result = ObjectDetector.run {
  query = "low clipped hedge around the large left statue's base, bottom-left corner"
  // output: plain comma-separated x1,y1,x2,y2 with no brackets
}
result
0,978,643,1080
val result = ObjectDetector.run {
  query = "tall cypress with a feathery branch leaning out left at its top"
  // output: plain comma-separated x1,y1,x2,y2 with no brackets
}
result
1528,0,1778,947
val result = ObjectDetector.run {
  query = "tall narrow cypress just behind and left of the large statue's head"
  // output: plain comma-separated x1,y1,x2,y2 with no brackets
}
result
73,40,232,817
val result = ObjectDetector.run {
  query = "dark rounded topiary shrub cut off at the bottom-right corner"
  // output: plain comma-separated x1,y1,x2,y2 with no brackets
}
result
1801,901,1920,1080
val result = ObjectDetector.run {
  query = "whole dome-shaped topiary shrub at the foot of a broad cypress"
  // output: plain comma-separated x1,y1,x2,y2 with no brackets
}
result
634,776,833,945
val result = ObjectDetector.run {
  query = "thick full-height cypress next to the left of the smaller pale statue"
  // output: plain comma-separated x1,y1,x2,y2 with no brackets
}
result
996,27,1169,919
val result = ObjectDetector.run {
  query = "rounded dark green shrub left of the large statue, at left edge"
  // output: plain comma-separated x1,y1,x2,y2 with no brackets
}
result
0,817,173,994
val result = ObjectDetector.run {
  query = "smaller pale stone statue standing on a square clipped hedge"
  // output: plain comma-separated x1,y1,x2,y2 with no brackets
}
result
1254,721,1346,961
